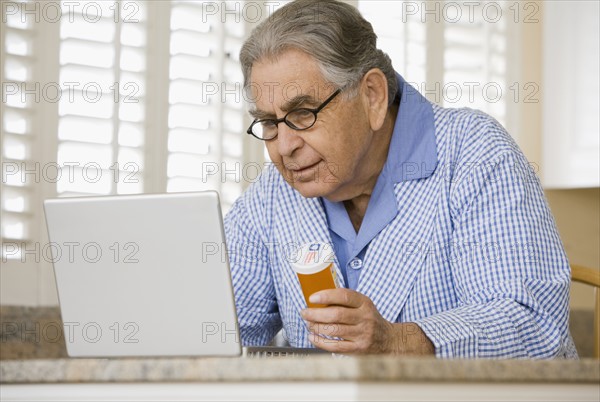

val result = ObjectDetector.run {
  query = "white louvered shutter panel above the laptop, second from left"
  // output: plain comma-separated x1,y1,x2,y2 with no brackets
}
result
57,1,147,196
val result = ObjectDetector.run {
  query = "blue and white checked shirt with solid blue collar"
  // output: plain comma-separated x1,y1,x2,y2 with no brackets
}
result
225,77,577,358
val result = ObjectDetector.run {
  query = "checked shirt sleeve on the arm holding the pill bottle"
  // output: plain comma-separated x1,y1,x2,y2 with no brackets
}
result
416,114,571,358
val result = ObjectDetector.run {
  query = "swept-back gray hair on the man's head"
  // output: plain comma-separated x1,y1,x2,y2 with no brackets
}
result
240,0,398,104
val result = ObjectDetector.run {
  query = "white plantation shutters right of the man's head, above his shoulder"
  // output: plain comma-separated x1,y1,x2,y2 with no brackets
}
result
358,0,508,131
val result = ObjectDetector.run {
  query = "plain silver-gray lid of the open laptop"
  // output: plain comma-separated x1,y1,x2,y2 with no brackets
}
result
44,191,241,357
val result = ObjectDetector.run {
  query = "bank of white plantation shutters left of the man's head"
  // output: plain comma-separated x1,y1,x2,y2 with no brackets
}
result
0,0,255,266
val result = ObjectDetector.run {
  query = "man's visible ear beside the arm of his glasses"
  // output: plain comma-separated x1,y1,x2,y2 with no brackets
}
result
362,68,388,131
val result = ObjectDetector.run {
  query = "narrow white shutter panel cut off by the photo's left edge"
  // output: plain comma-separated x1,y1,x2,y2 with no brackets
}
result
0,2,39,258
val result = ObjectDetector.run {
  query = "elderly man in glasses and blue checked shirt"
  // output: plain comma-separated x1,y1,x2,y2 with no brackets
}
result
225,0,576,358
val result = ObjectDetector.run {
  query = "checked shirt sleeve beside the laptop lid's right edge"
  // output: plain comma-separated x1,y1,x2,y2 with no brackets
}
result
224,183,282,346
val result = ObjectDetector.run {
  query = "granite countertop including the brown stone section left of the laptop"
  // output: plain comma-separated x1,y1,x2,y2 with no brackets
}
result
0,306,600,385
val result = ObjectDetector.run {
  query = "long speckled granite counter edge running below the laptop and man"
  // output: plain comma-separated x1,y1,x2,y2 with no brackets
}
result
0,356,600,384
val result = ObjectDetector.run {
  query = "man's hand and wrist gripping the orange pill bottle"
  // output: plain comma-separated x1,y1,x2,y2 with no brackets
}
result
302,289,435,355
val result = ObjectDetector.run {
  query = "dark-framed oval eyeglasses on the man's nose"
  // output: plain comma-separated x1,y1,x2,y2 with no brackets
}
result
246,89,342,141
